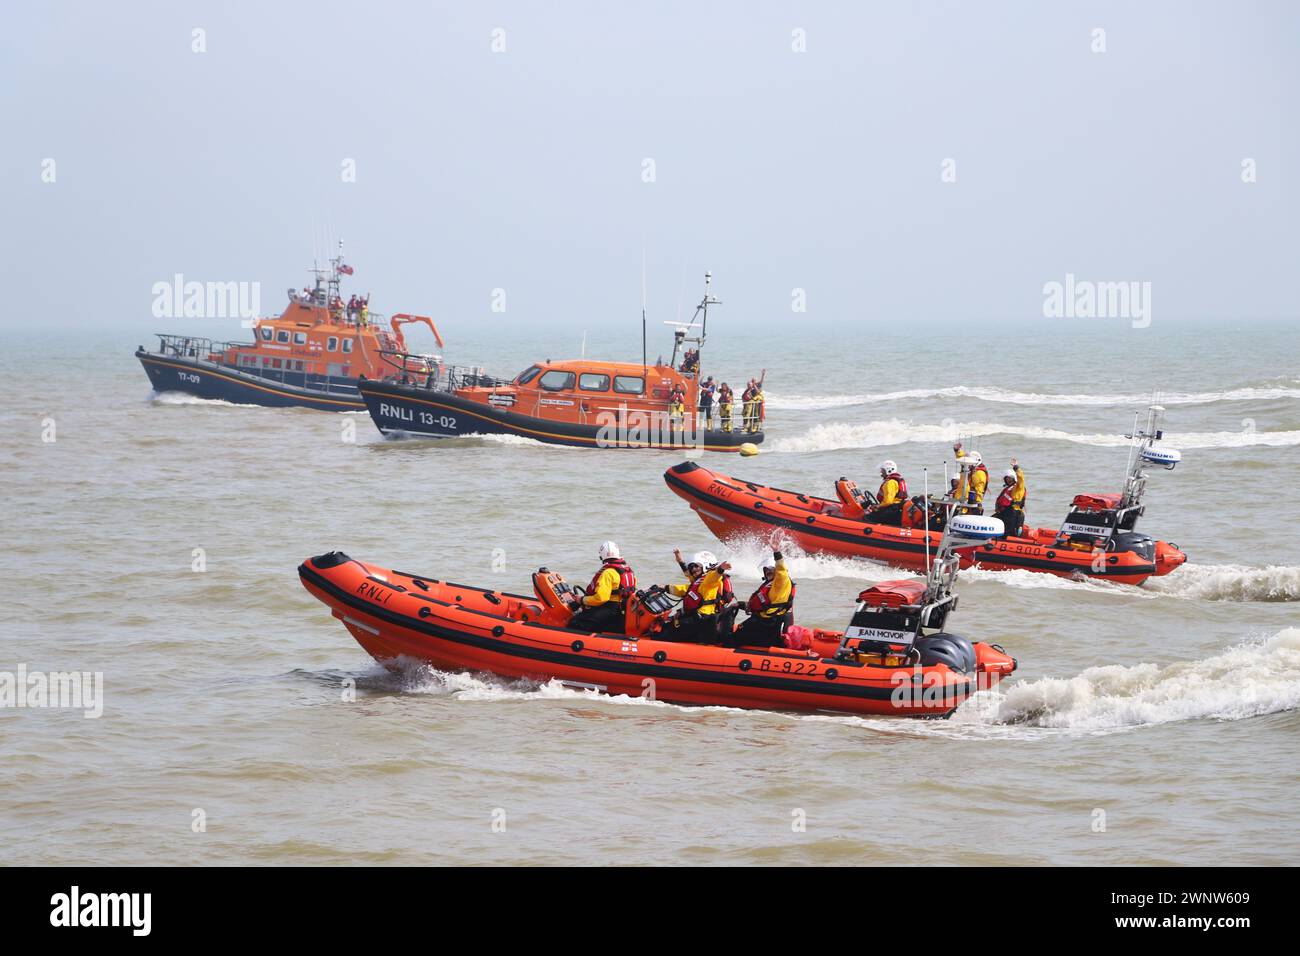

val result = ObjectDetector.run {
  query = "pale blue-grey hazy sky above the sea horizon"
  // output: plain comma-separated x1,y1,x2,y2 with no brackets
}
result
0,0,1300,333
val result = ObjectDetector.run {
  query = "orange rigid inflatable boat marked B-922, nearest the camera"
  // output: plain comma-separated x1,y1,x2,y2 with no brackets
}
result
298,538,1015,717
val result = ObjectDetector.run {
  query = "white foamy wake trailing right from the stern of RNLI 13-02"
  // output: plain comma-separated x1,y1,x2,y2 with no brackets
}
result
767,419,1300,454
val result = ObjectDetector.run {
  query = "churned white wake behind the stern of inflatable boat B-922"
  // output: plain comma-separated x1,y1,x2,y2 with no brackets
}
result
977,627,1300,732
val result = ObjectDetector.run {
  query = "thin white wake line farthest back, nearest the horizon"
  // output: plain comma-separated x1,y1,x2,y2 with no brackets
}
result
767,385,1300,411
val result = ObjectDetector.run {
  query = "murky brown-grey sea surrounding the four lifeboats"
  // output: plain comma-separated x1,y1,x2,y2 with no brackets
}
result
0,312,1300,866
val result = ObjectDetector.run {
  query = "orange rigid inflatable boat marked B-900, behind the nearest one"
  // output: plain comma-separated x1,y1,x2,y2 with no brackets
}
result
664,406,1187,584
